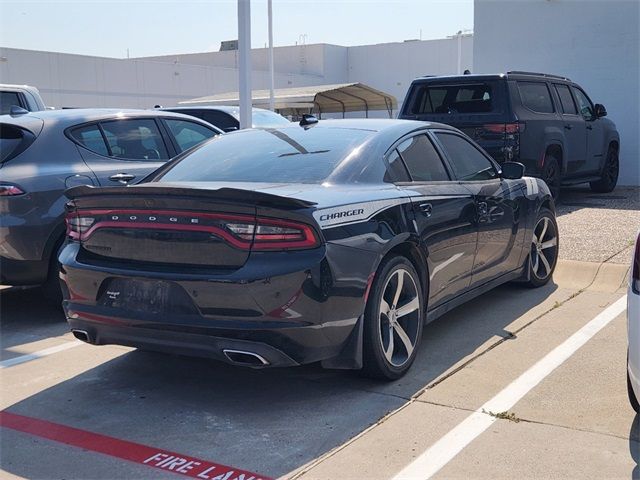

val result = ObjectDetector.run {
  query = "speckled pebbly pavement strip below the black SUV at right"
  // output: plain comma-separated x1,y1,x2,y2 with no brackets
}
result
557,186,640,264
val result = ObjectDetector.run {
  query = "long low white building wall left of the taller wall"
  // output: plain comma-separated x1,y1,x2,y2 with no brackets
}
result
0,37,473,116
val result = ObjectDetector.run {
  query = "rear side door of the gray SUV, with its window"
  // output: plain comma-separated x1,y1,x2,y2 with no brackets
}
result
69,118,175,186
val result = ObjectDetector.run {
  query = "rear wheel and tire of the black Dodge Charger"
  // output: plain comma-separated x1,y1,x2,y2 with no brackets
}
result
361,256,425,380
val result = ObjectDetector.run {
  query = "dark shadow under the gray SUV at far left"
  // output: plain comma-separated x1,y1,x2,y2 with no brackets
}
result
0,287,69,359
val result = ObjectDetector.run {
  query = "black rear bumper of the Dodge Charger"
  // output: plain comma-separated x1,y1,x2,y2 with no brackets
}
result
60,244,376,368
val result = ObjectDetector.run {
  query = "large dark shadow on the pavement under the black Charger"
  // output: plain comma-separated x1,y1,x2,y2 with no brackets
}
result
2,284,557,478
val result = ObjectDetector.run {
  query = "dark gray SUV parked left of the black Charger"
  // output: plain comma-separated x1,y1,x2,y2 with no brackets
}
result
0,109,222,297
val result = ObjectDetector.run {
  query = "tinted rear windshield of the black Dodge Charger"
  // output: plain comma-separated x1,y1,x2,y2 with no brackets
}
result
160,127,372,183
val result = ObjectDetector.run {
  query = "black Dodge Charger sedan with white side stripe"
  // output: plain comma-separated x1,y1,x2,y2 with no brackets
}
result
60,120,558,379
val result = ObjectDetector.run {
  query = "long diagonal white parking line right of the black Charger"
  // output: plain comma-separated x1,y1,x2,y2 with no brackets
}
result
393,295,627,480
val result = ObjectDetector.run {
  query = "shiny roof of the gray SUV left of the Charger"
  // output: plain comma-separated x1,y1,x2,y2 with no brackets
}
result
0,108,219,130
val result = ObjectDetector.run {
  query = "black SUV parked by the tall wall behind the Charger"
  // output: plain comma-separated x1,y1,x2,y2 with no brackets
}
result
399,72,620,198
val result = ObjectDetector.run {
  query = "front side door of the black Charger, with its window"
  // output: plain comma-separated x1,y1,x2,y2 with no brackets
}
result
434,130,524,288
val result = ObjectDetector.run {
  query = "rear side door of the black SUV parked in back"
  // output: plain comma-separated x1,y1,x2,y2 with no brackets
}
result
553,83,587,175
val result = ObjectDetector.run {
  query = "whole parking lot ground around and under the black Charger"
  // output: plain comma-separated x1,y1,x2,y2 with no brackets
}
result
0,189,640,480
